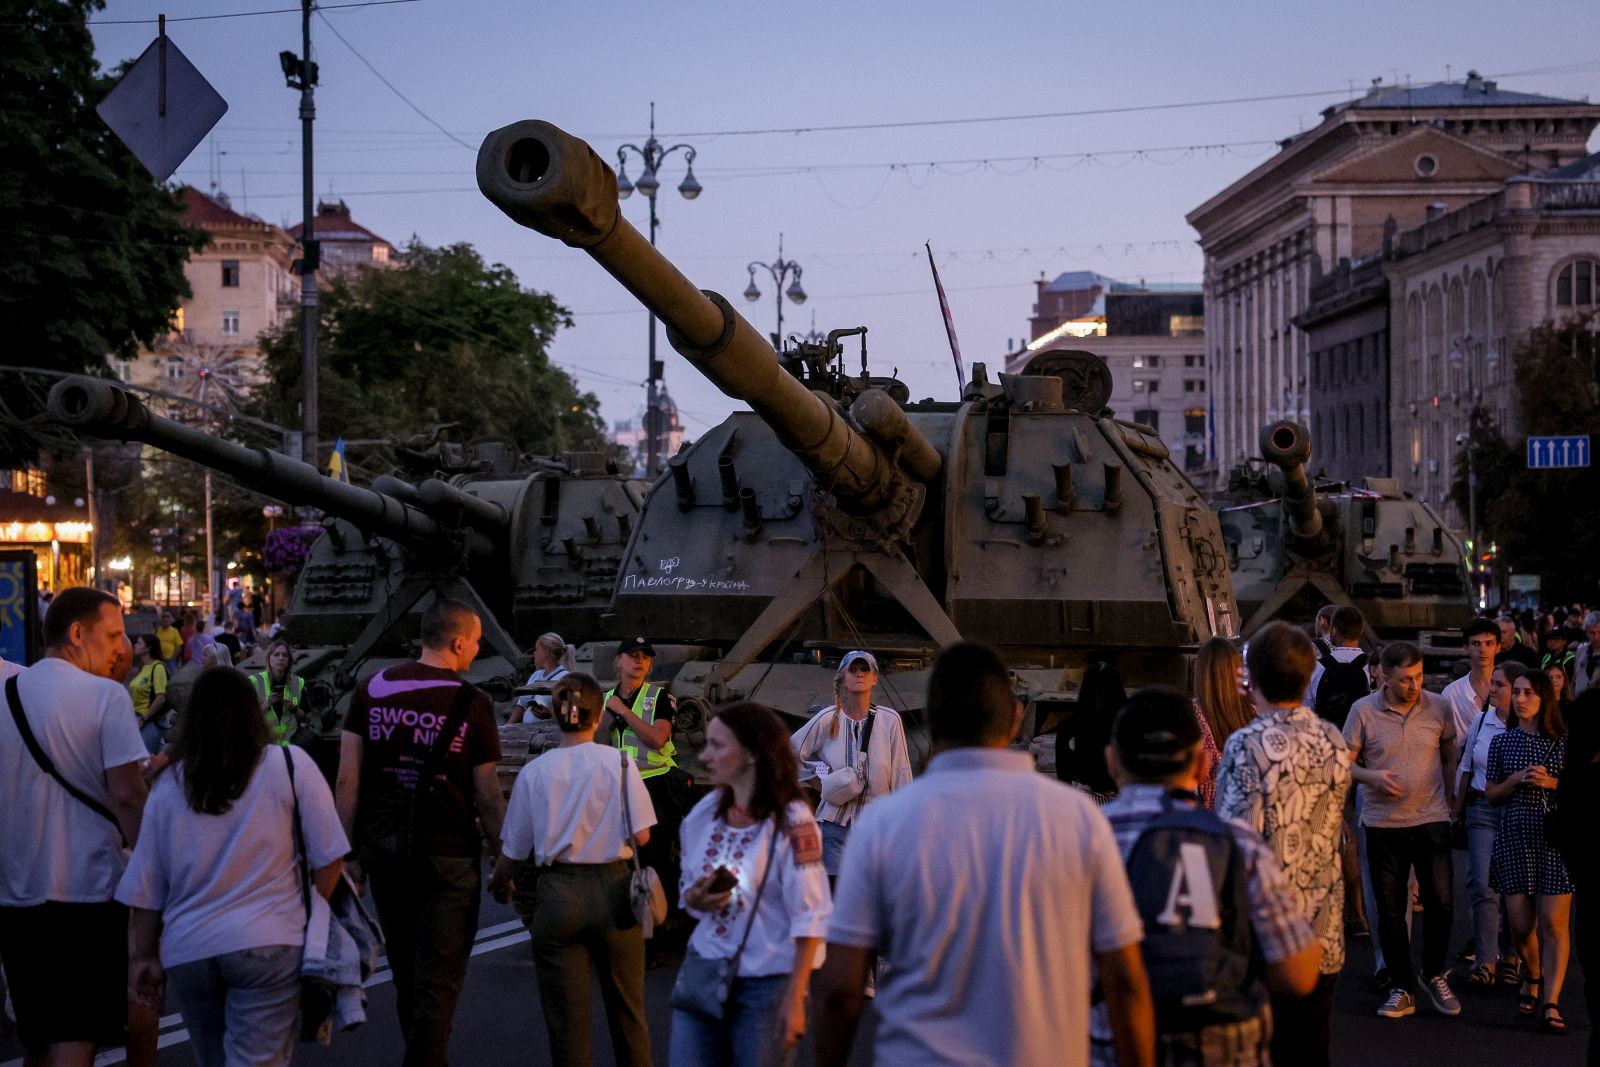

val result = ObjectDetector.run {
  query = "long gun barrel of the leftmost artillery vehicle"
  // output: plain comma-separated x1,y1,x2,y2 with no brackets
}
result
50,378,450,545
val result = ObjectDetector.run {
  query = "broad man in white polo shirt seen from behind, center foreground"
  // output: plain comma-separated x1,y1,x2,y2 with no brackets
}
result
813,643,1155,1067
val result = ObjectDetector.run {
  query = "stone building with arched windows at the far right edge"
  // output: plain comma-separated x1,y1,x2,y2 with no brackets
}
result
1384,155,1600,528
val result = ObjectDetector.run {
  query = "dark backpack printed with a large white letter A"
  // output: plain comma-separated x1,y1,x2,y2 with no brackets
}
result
1110,797,1266,1033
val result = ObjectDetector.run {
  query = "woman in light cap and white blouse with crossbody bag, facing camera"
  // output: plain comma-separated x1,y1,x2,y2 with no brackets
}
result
790,651,910,878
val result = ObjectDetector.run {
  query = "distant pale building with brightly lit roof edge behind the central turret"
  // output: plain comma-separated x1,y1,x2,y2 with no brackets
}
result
1005,283,1208,472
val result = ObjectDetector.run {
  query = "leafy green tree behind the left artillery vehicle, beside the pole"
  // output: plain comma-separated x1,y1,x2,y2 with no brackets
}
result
258,238,606,454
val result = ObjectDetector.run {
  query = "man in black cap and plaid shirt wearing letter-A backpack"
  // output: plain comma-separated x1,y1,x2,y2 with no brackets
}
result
1094,688,1322,1067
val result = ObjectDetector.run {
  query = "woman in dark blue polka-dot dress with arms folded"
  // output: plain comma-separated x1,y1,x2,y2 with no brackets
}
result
1485,670,1573,1033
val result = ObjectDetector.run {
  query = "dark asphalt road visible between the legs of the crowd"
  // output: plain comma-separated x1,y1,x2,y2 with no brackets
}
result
0,854,1589,1067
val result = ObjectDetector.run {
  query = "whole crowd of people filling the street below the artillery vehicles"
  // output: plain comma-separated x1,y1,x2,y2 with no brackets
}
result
0,589,1600,1067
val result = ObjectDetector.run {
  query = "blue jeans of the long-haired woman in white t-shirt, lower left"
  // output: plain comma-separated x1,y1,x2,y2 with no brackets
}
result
166,945,301,1067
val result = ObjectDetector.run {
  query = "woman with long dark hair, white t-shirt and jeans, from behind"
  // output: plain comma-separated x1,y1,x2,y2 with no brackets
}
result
117,667,350,1067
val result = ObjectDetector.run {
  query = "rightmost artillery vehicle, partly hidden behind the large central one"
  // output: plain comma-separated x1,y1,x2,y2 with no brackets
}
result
1218,419,1472,659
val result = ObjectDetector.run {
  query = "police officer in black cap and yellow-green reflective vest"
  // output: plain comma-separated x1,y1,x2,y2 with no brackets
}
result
602,637,691,927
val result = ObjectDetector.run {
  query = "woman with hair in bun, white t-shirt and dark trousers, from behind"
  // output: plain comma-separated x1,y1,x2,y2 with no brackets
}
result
490,673,656,1067
